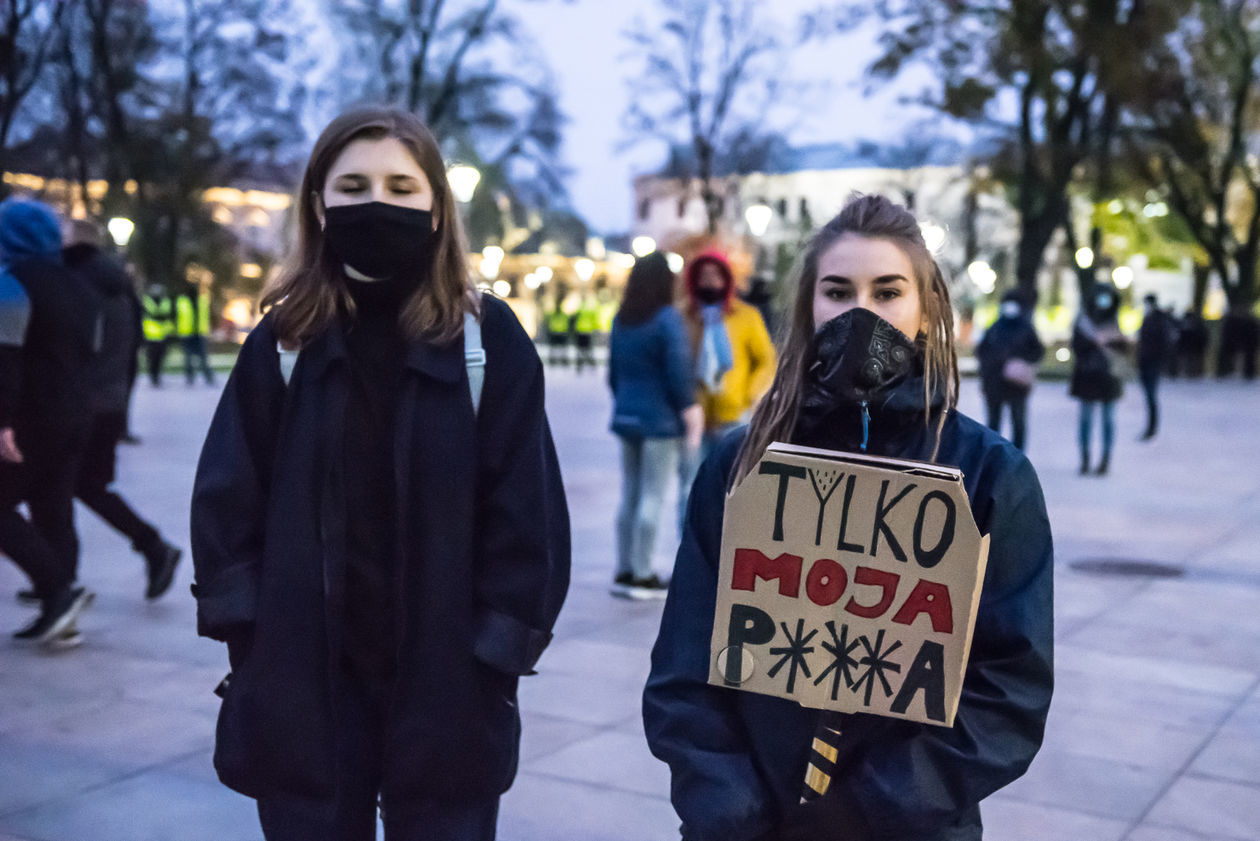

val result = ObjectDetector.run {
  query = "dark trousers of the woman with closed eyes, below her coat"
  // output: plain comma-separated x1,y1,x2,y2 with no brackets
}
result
258,675,499,841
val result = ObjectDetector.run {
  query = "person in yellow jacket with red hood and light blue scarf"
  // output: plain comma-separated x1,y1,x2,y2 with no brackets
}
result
678,251,777,523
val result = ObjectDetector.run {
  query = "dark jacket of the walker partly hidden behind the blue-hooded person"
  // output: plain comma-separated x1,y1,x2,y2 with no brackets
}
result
63,243,142,412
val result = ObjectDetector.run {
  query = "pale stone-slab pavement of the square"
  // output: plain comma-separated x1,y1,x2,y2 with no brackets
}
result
0,369,1260,841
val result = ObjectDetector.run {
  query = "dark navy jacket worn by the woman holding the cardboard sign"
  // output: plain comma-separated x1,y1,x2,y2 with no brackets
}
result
644,378,1053,841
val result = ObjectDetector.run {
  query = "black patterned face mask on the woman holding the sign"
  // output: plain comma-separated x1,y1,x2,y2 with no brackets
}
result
801,306,922,415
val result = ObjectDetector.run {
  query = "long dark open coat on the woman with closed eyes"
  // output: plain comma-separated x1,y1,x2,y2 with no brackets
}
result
192,296,570,801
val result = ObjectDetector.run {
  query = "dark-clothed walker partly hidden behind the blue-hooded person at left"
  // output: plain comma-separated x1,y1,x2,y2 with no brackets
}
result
62,219,181,600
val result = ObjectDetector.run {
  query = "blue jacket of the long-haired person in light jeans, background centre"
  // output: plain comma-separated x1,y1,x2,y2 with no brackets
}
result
609,306,696,439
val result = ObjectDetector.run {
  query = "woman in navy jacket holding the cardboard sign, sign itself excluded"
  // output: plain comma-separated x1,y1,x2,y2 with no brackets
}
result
643,195,1053,841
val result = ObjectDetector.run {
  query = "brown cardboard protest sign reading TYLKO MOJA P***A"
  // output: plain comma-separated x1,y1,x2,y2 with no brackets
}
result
709,444,989,726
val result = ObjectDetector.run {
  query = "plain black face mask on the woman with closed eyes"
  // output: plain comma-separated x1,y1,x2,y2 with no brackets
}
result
324,202,436,279
